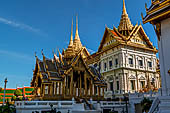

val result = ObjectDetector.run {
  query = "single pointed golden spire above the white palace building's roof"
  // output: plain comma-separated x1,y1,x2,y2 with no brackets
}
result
118,0,133,35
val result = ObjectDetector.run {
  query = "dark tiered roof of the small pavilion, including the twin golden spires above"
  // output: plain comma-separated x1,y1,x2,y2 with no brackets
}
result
31,17,105,86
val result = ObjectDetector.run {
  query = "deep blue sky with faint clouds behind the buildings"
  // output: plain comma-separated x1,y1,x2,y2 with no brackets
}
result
0,0,157,88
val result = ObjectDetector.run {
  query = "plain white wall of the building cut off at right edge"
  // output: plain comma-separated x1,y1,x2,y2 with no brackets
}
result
158,18,170,96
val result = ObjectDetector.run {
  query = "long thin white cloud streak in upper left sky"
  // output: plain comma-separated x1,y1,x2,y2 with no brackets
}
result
0,17,47,36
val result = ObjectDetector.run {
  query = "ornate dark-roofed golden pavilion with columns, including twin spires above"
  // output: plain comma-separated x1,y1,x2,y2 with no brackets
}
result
31,17,107,100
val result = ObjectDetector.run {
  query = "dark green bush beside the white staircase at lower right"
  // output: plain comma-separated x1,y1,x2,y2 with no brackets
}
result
141,98,152,113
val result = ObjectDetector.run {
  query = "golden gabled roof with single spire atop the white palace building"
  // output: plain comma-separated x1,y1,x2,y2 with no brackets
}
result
98,0,157,53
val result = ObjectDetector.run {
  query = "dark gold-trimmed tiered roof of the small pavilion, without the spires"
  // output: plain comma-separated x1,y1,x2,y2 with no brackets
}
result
34,47,105,84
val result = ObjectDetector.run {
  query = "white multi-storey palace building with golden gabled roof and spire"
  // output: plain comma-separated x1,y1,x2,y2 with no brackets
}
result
88,0,160,94
